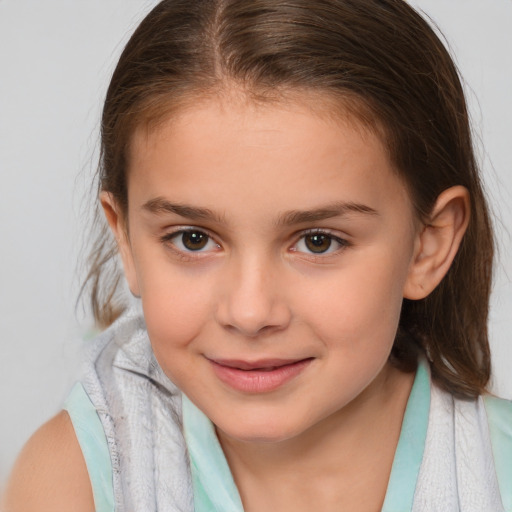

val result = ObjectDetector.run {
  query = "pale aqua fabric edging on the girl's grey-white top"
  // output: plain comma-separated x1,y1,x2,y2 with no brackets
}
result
65,361,512,512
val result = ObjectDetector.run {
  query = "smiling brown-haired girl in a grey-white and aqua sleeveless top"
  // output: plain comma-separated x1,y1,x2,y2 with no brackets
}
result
6,0,512,512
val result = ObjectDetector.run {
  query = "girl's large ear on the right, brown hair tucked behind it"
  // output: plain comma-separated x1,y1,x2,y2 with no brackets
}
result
404,186,470,300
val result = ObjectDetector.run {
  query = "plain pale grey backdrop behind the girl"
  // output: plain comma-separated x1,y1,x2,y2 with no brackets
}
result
0,0,512,487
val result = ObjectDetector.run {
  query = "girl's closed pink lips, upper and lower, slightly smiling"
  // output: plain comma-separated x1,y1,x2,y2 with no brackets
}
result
209,358,313,393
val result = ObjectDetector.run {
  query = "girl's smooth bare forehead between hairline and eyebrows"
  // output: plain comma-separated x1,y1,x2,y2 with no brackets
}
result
128,98,412,222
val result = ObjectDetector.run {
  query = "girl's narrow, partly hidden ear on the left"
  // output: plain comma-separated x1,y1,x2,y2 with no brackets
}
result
100,192,140,297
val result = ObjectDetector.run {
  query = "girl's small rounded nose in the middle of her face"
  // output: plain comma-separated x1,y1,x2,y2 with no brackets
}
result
217,257,291,337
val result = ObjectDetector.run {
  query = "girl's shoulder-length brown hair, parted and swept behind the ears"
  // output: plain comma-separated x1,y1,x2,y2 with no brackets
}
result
86,0,493,396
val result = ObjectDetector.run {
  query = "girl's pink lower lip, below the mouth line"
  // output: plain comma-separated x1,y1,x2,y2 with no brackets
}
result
210,359,312,393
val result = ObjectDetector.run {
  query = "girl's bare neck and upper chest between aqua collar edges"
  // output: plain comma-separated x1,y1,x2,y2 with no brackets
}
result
217,365,414,512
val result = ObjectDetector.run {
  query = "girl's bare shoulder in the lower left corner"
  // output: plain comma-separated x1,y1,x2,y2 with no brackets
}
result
0,411,94,512
